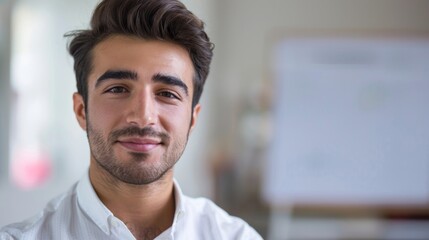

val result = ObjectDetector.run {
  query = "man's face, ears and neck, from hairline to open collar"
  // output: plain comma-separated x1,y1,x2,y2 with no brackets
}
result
73,35,200,239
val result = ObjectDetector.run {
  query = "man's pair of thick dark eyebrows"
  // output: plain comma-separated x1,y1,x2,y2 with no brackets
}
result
95,70,188,96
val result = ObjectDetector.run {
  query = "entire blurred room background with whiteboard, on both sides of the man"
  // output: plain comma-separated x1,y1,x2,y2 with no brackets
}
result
0,0,429,239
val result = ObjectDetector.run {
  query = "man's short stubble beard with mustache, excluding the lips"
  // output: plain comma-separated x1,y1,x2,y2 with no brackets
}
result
87,120,189,185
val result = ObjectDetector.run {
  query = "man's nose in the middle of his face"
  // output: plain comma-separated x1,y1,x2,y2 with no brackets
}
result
127,91,157,128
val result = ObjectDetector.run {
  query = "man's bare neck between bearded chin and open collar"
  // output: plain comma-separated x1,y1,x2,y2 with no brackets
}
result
89,159,175,239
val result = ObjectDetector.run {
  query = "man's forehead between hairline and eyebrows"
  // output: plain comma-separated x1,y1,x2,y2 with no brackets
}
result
89,35,194,87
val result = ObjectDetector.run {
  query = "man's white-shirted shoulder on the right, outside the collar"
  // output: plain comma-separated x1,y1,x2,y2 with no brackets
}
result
183,196,262,239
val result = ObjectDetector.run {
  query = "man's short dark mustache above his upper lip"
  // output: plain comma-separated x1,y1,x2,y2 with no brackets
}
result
109,127,170,143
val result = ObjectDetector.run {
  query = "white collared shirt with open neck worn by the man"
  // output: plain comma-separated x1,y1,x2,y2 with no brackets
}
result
0,174,262,240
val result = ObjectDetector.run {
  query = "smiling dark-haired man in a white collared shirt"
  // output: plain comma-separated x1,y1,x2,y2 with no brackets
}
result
0,0,261,240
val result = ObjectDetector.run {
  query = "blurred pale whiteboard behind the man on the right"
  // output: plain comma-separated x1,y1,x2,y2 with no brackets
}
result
263,38,429,205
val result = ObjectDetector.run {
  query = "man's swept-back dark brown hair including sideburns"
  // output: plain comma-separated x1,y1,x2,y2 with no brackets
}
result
65,0,214,107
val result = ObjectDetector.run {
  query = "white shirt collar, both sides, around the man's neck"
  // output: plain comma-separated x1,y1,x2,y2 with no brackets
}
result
76,172,185,234
